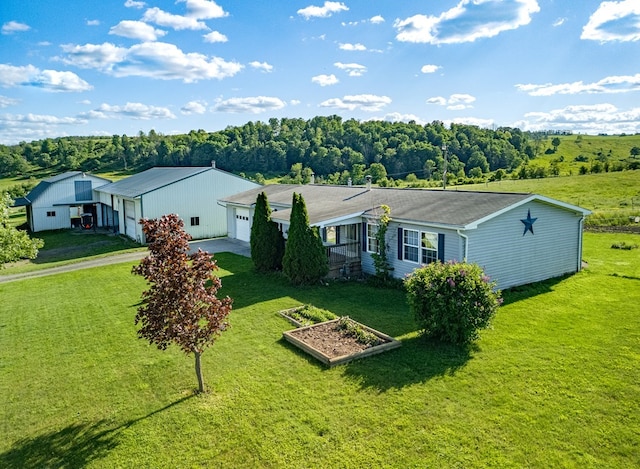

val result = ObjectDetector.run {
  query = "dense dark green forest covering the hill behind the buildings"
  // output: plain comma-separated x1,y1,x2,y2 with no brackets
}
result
0,116,632,185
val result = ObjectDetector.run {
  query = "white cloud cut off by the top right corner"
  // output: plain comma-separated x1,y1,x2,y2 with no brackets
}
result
580,0,640,42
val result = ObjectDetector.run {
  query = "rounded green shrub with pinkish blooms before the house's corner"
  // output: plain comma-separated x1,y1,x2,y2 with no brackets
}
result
404,262,502,344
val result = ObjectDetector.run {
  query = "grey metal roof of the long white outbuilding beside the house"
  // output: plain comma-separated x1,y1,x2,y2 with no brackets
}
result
96,166,215,198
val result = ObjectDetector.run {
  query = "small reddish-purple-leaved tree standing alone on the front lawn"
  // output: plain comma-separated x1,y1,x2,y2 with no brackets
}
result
132,214,233,392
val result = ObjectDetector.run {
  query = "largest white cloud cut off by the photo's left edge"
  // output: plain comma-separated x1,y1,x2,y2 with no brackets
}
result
0,64,93,92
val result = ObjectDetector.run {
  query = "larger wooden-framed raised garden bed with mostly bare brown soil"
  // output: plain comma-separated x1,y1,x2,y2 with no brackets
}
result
280,308,402,367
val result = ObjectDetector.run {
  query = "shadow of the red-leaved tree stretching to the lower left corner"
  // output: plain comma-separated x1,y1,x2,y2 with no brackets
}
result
0,395,193,469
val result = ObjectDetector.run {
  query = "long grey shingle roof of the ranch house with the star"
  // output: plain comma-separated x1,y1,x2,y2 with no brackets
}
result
221,184,588,228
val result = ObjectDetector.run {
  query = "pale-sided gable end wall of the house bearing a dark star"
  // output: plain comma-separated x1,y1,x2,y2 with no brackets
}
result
465,198,582,289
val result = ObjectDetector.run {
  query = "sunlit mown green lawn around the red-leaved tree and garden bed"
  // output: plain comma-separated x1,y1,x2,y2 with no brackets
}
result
0,233,640,468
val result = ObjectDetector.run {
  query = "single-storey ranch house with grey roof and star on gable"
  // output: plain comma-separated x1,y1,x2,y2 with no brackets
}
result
220,184,590,289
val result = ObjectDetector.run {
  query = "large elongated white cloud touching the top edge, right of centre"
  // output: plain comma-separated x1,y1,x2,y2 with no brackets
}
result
393,0,540,44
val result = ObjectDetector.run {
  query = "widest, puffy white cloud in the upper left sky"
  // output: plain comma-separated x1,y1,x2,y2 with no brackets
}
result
61,42,243,83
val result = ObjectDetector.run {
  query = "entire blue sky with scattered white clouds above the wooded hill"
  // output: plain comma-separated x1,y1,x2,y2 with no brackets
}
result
0,0,640,144
